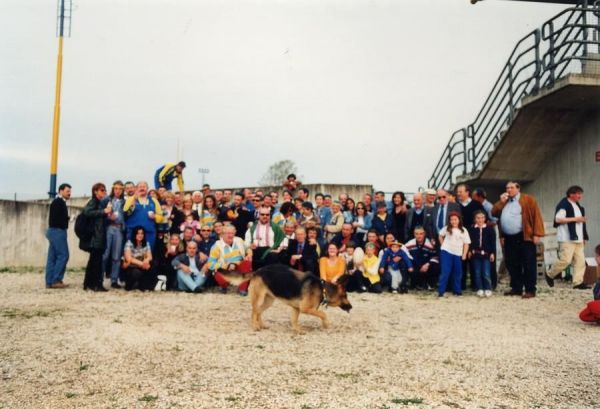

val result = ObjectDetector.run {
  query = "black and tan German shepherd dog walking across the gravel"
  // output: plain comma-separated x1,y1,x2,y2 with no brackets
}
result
219,264,352,334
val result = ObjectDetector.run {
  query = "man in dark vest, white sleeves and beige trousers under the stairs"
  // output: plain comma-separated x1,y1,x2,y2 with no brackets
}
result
546,186,590,290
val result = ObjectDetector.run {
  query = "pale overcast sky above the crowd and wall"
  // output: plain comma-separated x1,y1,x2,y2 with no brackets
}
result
0,0,565,197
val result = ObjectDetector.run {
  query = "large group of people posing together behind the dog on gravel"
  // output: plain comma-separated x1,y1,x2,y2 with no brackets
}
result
46,162,589,298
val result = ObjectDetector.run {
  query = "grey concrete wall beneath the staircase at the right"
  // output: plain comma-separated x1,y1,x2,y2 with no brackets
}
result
523,111,600,257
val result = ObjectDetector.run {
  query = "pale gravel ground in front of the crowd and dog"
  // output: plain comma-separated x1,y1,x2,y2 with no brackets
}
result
0,273,600,409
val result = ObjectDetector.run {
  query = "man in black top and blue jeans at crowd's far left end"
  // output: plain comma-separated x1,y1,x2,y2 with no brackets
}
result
46,183,71,288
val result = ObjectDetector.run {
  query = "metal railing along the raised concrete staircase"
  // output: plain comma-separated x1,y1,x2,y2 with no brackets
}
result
427,0,600,188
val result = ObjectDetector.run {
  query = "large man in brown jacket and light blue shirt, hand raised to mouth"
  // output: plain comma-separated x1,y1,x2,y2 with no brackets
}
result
492,181,545,298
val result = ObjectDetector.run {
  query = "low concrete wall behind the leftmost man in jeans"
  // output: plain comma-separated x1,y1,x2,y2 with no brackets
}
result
0,200,88,267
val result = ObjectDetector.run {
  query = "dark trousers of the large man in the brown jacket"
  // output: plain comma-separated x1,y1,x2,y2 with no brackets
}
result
504,234,537,293
